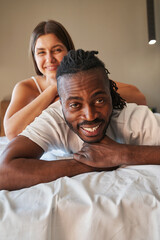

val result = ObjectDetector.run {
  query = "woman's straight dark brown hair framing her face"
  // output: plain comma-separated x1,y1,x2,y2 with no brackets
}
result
30,20,75,75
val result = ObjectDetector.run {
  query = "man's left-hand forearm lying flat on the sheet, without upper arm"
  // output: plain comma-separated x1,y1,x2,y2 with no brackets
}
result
0,159,94,190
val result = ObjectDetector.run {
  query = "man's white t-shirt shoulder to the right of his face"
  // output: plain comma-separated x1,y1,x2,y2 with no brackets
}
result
108,103,160,145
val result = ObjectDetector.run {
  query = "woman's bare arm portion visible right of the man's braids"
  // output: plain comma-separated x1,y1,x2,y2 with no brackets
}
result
115,82,147,105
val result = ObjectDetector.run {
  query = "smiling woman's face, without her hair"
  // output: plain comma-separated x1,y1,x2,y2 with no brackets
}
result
35,33,67,79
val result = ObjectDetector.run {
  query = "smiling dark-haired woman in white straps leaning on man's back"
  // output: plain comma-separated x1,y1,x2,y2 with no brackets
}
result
4,20,146,139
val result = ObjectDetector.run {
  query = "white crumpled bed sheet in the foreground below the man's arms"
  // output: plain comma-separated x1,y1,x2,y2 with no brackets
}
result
0,165,160,240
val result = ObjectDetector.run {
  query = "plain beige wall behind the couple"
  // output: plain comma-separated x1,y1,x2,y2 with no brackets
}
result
0,0,160,112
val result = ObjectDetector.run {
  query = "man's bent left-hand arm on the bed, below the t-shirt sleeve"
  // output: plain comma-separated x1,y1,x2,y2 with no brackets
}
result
0,136,99,190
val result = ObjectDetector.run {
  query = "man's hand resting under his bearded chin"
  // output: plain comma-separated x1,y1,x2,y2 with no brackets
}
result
74,136,125,168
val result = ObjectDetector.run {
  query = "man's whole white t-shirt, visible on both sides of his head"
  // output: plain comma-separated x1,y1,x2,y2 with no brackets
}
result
20,101,160,154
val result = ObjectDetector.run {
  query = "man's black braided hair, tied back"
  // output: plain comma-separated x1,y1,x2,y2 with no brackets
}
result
56,49,126,110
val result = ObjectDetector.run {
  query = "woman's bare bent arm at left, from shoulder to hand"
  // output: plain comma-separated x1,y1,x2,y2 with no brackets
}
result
4,81,57,139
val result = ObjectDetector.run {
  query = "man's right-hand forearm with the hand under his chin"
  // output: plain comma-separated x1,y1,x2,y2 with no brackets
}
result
74,136,160,168
